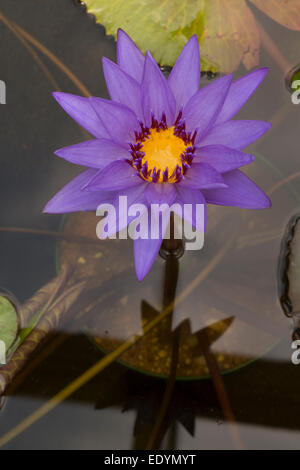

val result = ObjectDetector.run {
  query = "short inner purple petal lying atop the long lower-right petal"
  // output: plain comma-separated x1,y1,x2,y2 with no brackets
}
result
178,163,226,189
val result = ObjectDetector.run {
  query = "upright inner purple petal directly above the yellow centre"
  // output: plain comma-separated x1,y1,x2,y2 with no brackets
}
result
142,52,176,126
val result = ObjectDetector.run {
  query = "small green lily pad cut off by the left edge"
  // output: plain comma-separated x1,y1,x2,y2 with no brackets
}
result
0,296,18,350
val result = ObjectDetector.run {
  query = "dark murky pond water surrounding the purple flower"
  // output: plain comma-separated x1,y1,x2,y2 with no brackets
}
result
0,0,300,450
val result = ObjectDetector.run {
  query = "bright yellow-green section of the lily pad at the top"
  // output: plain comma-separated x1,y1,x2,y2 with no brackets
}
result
84,0,217,72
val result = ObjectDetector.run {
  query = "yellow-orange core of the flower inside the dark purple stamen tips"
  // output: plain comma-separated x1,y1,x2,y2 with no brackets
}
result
141,127,188,183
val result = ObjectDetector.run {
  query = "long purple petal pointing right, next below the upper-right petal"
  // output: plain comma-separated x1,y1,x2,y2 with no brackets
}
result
198,121,272,150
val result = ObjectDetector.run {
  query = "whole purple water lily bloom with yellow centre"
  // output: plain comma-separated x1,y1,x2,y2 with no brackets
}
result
44,30,271,280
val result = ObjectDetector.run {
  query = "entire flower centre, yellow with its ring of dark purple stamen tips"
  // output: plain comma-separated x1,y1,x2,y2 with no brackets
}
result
129,115,194,183
